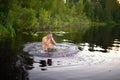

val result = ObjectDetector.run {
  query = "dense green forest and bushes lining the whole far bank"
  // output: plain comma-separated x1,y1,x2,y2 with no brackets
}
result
0,0,120,37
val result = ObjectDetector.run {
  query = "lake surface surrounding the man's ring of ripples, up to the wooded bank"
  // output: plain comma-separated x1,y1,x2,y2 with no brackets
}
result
0,25,120,80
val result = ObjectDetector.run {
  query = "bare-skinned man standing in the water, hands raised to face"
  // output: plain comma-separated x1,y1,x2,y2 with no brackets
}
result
42,32,56,50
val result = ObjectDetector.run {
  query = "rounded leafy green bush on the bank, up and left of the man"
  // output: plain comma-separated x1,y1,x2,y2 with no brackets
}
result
16,8,37,30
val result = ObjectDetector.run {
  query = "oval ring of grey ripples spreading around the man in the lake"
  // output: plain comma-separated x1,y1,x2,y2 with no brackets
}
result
23,42,79,57
